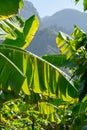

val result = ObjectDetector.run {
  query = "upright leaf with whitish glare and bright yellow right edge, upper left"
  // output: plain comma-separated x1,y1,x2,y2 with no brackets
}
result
0,15,39,49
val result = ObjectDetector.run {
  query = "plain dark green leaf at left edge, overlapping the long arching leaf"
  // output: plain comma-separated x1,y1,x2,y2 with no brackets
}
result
0,52,25,93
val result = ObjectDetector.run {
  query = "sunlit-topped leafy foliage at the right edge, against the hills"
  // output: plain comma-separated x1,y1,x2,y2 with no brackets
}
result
56,26,87,100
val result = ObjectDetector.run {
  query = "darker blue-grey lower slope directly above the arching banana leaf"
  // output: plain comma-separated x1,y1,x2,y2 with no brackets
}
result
28,28,59,56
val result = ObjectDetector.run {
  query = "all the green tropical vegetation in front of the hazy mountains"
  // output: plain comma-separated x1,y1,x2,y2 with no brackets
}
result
0,0,87,130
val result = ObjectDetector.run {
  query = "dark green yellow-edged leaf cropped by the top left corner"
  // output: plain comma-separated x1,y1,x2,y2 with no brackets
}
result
0,0,23,20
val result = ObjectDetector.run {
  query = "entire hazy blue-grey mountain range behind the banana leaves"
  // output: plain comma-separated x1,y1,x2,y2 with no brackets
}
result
18,1,87,56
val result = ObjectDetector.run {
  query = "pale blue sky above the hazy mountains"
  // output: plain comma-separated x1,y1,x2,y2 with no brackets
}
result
28,0,83,17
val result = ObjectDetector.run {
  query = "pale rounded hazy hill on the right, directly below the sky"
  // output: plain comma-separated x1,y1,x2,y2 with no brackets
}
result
41,9,87,34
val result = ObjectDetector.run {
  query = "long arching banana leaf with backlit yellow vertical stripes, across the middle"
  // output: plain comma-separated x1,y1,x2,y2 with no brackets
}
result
0,45,77,100
